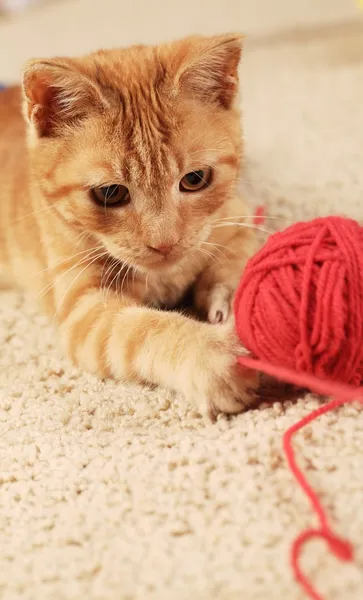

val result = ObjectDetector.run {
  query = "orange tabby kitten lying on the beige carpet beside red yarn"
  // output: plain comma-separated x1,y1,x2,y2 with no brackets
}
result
0,35,255,418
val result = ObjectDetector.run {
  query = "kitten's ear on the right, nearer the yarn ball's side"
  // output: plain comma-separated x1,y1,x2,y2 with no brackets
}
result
174,34,243,108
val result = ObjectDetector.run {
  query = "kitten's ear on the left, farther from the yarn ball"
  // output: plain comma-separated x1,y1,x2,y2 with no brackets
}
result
23,59,105,137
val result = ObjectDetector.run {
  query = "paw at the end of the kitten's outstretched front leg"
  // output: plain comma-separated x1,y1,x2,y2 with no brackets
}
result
191,325,259,421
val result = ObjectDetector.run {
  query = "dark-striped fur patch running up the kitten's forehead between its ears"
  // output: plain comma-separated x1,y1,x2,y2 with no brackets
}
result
87,53,179,188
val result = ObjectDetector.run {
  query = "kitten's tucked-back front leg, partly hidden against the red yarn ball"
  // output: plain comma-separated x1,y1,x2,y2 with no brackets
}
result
194,227,256,324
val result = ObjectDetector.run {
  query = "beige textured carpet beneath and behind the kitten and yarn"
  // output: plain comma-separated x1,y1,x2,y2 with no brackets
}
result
0,4,363,600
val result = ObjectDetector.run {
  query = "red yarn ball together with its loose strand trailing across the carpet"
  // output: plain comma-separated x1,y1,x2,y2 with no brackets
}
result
234,210,363,600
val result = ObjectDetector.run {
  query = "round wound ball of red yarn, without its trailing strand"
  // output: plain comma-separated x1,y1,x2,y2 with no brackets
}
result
234,217,363,385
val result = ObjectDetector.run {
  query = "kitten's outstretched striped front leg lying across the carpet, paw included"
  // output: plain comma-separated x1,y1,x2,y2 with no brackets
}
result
47,264,257,418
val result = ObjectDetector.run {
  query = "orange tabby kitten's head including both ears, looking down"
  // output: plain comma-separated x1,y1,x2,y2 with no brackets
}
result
23,35,242,271
